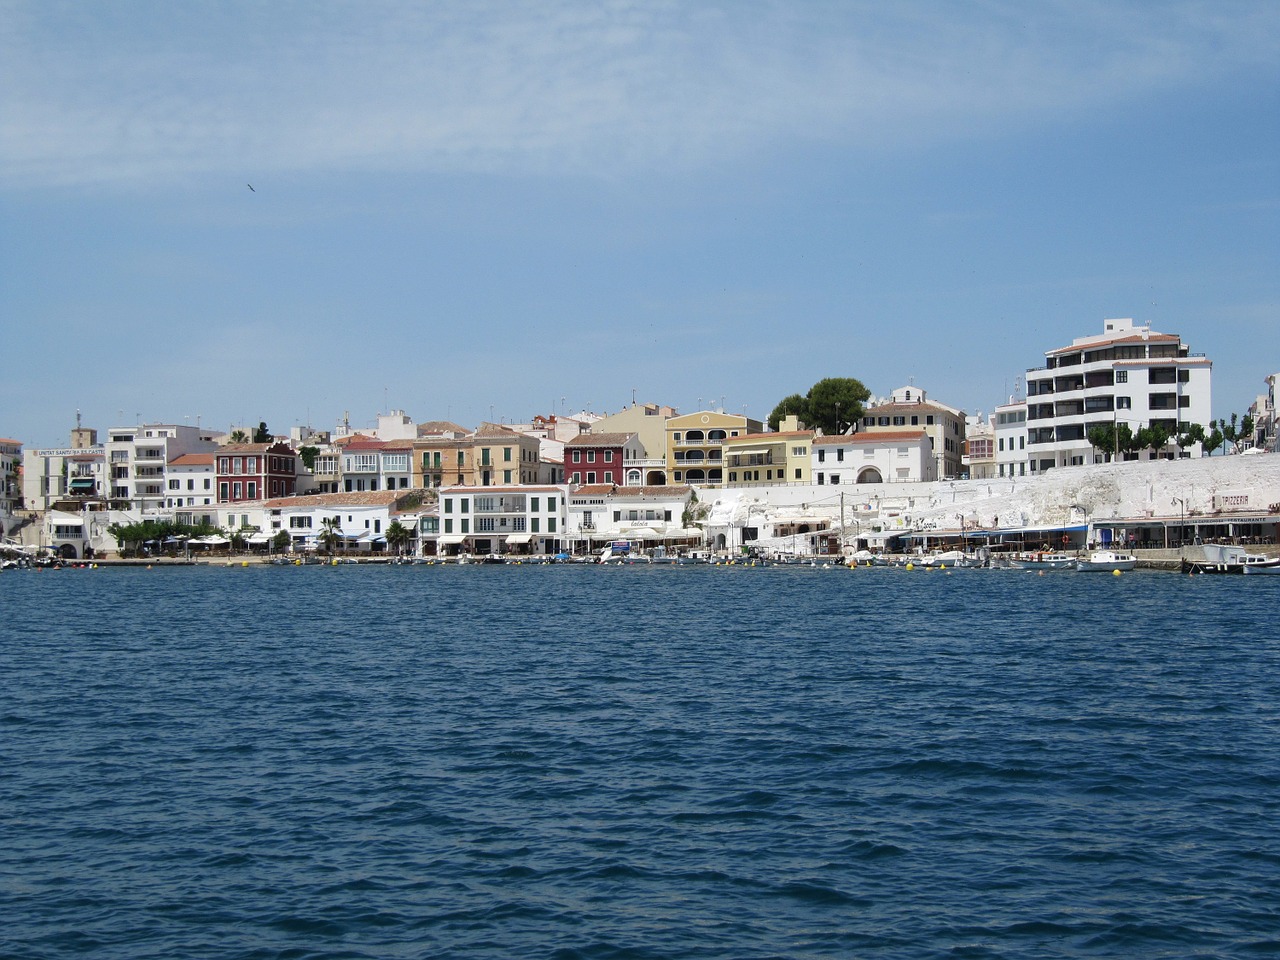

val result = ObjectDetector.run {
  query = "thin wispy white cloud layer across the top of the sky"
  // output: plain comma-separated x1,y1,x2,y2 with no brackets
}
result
0,0,1280,184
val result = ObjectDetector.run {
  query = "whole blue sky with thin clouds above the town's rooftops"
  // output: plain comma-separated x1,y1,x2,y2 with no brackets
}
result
0,0,1280,445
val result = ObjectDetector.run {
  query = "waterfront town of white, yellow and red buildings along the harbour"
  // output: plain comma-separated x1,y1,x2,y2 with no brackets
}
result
0,319,1280,563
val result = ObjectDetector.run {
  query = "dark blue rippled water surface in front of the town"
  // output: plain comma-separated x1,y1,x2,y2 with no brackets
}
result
0,566,1280,960
